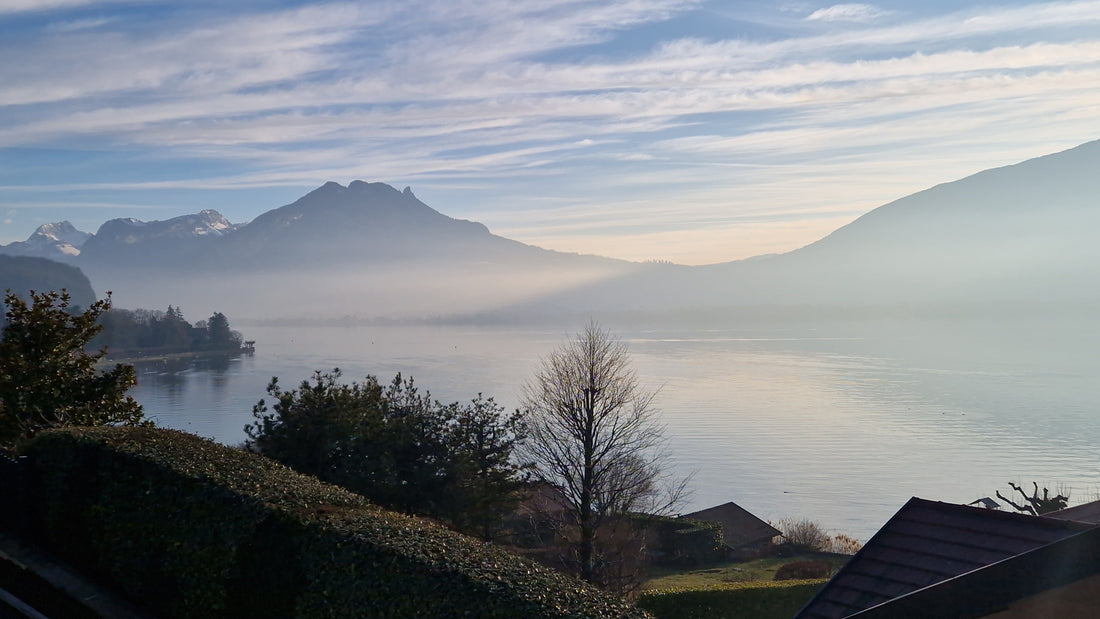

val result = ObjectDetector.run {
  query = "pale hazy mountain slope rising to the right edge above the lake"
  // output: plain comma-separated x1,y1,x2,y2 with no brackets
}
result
509,141,1100,316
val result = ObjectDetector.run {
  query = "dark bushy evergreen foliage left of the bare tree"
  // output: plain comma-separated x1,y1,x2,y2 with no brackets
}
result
245,369,525,537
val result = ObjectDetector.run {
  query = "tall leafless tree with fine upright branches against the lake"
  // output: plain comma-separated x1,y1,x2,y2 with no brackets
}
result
523,322,688,584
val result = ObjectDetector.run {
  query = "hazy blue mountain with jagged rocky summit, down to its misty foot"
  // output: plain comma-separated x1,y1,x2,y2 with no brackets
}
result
73,180,636,317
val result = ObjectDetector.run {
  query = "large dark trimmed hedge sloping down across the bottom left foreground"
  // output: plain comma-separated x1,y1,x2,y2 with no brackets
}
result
26,428,646,618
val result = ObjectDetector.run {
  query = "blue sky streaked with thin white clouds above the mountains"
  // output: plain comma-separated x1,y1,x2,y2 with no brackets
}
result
0,0,1100,264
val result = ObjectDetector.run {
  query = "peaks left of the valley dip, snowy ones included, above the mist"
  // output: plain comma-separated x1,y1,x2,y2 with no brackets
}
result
0,180,607,272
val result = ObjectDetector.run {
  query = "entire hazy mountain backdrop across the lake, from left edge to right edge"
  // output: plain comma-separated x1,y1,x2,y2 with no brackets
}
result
0,141,1100,325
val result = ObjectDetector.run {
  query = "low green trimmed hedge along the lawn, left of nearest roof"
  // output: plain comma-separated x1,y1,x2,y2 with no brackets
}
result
637,581,825,619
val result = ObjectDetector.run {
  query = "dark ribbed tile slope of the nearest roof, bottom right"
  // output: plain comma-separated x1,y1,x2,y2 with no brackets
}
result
796,497,1093,619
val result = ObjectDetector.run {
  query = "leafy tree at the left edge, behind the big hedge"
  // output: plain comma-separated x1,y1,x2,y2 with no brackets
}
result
0,290,143,447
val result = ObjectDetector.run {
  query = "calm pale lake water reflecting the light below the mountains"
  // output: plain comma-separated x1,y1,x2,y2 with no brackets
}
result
133,321,1100,540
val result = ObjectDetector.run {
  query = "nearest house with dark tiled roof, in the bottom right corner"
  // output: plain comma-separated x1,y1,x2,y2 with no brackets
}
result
795,498,1100,619
